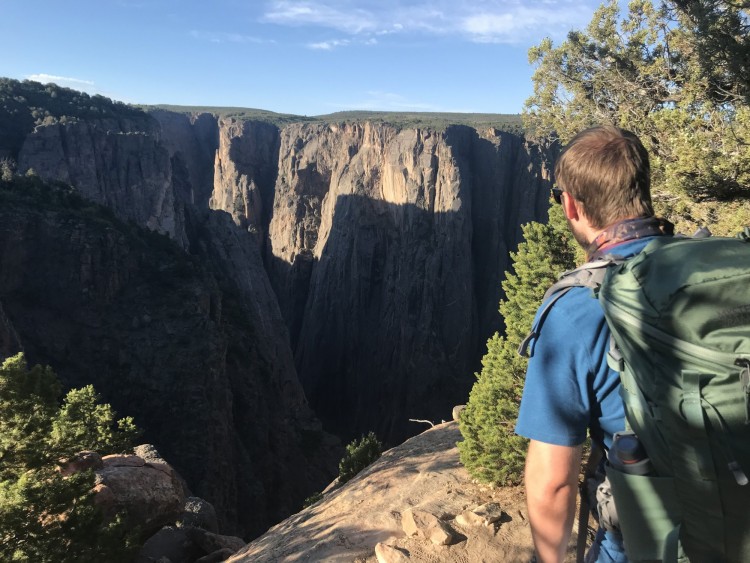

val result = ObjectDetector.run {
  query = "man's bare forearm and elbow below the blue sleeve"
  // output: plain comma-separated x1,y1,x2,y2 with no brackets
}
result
525,440,582,563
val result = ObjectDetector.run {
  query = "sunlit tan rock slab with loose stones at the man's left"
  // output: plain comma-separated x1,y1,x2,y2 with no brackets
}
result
228,422,548,563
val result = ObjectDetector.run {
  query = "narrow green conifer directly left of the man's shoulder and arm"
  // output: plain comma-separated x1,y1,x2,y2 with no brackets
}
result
458,206,575,485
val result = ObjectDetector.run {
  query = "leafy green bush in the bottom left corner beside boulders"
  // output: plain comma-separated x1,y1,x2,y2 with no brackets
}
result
0,354,138,562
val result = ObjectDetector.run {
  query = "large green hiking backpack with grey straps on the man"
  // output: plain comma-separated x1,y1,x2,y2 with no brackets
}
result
519,229,750,563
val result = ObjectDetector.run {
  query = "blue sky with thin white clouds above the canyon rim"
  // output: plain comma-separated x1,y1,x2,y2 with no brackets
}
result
0,0,600,115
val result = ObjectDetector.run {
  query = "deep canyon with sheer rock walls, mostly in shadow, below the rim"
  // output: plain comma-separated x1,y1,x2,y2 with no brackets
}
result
0,81,550,539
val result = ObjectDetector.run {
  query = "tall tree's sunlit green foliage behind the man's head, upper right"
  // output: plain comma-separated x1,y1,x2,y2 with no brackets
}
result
524,0,750,230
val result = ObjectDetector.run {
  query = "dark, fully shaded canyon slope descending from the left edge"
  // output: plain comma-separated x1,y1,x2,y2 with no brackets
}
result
0,186,335,537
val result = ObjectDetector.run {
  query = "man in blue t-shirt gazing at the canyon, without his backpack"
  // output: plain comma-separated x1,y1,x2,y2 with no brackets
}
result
516,126,671,563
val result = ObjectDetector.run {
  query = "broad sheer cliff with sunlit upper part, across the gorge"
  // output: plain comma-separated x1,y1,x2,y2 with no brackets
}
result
267,123,548,442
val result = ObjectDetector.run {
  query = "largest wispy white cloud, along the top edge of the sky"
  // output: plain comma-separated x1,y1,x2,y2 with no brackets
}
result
262,0,599,43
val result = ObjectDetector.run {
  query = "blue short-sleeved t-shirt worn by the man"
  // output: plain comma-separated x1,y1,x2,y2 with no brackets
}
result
516,237,653,447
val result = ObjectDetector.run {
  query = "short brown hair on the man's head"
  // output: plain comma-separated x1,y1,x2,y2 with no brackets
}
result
555,126,654,229
